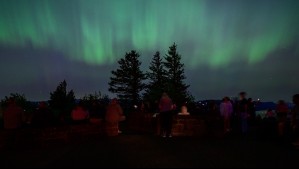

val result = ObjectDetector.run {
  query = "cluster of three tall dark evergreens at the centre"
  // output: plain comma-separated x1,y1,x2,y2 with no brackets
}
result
109,43,193,104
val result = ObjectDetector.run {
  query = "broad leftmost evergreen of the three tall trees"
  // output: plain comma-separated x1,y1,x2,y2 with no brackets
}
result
109,50,145,104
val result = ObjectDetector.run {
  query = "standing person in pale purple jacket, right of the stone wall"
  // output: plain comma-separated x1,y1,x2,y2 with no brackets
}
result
220,97,233,133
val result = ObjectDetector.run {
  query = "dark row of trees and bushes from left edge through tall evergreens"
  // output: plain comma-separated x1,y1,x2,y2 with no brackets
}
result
0,43,193,114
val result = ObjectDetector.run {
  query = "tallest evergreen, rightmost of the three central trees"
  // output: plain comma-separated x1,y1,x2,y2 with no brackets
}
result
164,43,190,104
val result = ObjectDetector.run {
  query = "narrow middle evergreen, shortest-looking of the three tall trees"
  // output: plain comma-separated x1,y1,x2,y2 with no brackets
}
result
144,51,166,102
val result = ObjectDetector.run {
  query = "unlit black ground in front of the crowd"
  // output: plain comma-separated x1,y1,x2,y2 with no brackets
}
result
0,134,299,168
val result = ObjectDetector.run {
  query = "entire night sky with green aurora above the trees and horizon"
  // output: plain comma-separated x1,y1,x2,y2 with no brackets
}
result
0,0,299,101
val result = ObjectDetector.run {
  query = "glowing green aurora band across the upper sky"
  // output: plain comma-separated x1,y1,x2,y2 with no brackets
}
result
0,0,299,68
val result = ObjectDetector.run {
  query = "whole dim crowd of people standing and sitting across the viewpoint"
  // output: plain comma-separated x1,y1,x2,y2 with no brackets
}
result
3,92,299,148
